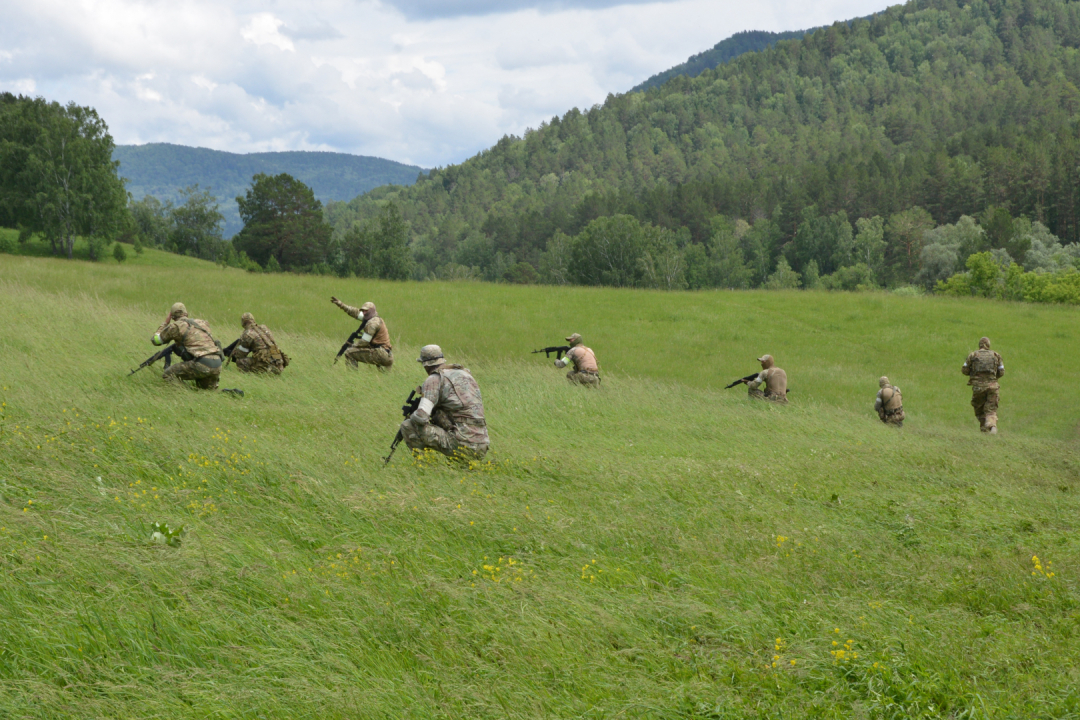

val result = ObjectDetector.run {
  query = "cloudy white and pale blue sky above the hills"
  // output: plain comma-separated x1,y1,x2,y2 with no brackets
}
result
0,0,889,167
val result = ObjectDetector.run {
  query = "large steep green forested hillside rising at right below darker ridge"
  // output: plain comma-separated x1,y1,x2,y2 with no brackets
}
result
328,0,1080,287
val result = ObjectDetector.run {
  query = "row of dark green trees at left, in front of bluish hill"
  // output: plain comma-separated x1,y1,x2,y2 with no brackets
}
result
0,93,411,280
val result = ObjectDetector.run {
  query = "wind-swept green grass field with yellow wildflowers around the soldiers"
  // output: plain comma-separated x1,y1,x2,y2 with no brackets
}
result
0,250,1080,718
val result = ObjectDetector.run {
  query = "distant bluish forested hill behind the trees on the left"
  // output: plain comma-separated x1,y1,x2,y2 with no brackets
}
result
112,142,424,237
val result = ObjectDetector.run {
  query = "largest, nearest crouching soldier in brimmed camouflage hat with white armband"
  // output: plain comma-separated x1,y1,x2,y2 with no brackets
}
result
401,345,488,460
